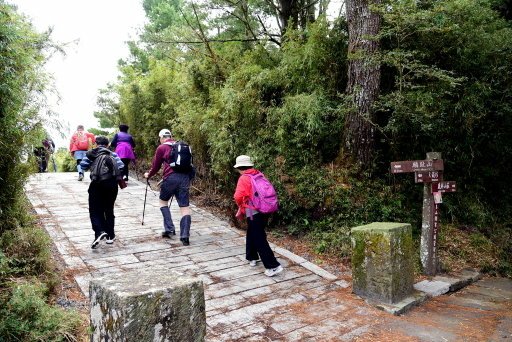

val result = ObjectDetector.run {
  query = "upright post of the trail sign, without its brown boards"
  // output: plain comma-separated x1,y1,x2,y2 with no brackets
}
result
420,152,441,275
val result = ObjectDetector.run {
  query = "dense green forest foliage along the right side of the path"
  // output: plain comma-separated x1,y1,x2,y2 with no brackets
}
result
91,0,512,270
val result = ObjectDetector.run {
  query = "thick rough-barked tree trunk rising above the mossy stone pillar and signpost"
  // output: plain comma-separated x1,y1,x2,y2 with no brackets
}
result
344,0,381,169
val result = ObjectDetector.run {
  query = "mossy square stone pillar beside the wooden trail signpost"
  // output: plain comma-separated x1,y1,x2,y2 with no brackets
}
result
351,222,414,304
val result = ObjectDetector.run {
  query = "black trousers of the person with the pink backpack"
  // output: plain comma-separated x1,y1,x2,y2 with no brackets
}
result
245,213,280,269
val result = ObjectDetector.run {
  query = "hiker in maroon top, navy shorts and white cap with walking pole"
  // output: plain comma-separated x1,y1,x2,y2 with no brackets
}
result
144,129,194,246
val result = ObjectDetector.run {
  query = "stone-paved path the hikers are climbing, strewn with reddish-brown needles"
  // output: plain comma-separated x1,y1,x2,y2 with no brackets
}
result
26,173,512,341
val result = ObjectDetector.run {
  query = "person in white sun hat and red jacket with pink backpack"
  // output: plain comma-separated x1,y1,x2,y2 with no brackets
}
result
234,155,283,277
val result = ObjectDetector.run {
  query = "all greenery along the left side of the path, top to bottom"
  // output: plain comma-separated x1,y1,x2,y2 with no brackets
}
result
0,0,82,341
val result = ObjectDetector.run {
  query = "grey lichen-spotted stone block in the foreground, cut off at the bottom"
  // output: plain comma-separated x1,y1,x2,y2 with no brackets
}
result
89,268,206,342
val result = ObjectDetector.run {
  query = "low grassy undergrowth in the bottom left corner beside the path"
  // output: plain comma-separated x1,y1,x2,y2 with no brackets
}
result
0,210,84,342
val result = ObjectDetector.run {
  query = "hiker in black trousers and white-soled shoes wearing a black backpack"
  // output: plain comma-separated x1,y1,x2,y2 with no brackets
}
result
80,136,124,249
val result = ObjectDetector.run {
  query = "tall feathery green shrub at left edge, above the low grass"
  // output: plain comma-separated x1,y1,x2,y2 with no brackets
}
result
0,2,48,233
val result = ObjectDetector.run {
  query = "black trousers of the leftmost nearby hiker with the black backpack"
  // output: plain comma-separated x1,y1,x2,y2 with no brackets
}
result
89,179,118,238
